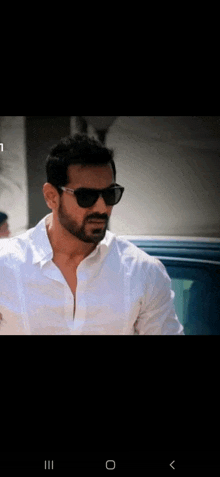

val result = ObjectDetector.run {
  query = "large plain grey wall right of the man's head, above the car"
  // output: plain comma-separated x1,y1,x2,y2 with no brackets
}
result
106,116,220,237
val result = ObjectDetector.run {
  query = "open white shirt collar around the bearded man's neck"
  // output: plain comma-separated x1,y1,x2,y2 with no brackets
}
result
30,214,115,265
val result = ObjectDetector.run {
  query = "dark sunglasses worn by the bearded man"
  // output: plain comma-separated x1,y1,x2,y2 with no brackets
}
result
59,184,124,208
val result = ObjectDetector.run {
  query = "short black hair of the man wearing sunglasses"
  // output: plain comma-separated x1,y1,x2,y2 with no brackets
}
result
46,134,116,196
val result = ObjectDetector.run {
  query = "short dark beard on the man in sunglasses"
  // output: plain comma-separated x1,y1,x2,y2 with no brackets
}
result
58,203,109,244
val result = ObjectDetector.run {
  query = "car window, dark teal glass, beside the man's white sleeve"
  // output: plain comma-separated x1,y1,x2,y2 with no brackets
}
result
163,260,220,335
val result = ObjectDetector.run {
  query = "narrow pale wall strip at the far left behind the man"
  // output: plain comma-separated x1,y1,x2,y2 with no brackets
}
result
0,116,28,236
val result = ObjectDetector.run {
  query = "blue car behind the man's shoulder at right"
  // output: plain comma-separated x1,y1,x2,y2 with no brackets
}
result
118,235,220,335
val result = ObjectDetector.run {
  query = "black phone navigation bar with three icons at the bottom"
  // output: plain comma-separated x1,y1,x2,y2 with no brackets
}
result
0,451,220,470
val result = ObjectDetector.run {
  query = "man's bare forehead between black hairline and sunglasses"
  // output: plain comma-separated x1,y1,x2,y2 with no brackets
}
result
68,164,114,189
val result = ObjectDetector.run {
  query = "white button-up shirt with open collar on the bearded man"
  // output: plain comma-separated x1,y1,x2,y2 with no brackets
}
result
0,214,184,335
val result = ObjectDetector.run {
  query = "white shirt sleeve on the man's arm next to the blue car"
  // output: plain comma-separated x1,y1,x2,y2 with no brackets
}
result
134,258,184,335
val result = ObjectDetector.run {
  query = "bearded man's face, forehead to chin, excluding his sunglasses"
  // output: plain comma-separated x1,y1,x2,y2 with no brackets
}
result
57,164,114,244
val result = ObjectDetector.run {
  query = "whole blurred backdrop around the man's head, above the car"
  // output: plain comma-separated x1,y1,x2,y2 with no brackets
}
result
0,116,220,238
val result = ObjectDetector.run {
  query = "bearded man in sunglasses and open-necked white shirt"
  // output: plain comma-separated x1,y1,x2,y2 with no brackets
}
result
0,134,184,335
